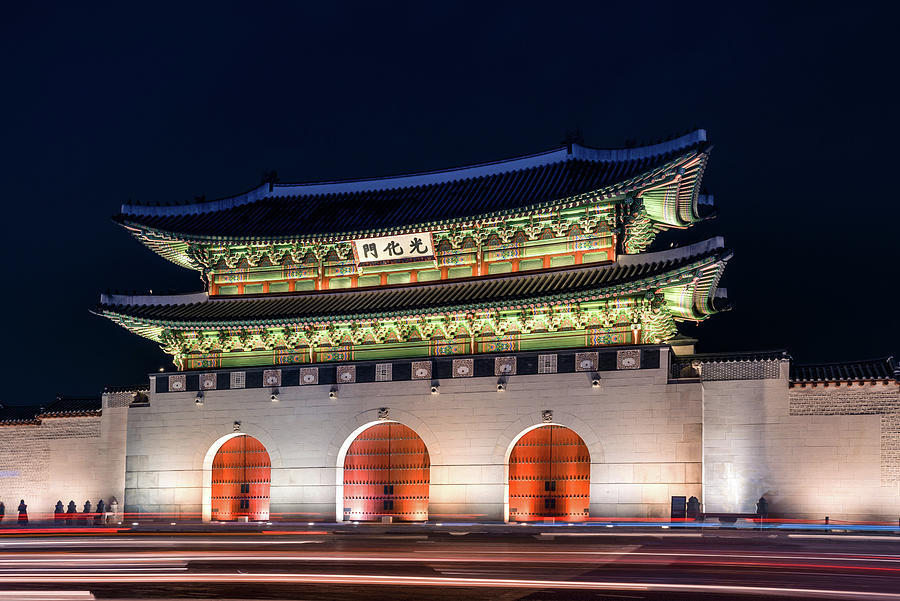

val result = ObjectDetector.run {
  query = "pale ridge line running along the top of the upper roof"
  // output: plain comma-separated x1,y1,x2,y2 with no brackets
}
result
121,129,706,216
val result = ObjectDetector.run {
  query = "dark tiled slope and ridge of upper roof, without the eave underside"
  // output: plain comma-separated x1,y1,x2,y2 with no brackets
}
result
116,135,706,237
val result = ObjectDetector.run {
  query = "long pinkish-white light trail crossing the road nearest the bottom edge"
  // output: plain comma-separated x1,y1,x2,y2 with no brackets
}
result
3,573,900,601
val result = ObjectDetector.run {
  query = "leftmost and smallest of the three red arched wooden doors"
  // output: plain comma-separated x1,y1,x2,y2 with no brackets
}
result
212,434,272,521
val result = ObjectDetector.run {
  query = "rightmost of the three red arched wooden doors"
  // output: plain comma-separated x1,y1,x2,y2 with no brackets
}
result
509,425,591,522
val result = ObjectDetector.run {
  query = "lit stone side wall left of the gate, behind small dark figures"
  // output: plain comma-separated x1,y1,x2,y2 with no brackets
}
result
0,394,128,521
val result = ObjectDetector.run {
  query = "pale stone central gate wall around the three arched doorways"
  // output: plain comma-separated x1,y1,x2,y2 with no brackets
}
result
125,349,702,521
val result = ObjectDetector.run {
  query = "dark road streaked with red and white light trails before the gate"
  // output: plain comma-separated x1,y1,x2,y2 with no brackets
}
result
0,527,900,601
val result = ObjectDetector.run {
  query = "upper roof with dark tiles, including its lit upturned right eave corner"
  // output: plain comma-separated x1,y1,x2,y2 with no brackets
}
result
116,130,707,240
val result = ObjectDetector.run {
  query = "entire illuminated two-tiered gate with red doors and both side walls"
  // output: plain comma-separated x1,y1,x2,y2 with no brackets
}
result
0,130,900,522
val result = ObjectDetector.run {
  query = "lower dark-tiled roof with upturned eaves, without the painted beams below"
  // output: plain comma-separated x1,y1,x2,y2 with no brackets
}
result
97,238,731,338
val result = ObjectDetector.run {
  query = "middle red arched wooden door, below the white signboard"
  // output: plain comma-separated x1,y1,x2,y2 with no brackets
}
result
344,422,431,521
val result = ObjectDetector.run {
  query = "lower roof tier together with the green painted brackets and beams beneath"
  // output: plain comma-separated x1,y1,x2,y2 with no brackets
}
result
98,238,730,369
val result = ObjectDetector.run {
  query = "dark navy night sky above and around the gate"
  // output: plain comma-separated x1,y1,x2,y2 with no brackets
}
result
0,2,900,404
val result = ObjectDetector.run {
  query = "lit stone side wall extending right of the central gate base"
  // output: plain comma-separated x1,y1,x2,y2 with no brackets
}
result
703,361,900,521
